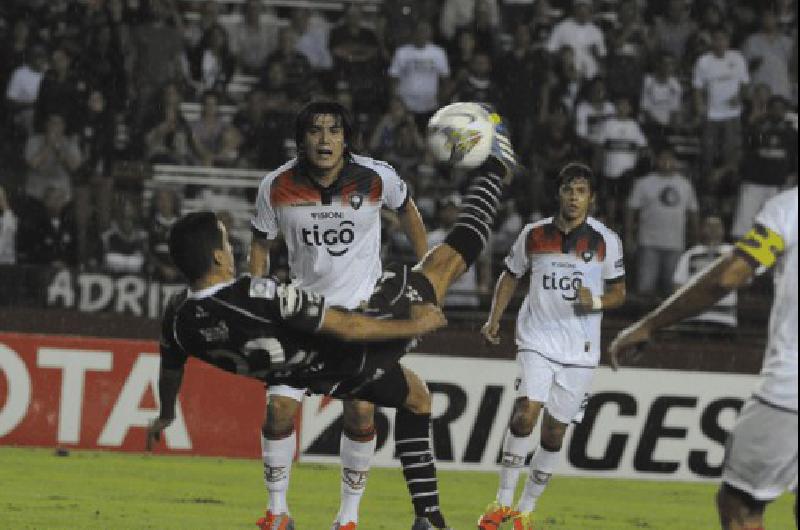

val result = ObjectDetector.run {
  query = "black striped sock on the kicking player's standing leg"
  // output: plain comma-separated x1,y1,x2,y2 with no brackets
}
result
395,409,447,528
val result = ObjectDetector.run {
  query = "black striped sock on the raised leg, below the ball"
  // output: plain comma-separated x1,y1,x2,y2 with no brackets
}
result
444,169,503,268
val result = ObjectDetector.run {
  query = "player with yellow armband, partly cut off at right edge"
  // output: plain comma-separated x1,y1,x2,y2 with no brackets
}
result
609,186,798,530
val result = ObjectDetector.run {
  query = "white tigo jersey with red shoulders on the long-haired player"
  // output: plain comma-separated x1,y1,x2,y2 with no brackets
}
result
252,155,408,309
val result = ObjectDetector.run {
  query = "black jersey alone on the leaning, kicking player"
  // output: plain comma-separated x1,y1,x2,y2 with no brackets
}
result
161,276,364,383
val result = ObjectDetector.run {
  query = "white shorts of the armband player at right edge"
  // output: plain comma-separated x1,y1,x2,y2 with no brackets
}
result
722,399,797,501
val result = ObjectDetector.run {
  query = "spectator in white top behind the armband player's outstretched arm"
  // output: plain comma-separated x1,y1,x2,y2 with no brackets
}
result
672,215,738,328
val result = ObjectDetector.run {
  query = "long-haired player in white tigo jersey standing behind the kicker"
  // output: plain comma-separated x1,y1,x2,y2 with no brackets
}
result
250,101,427,530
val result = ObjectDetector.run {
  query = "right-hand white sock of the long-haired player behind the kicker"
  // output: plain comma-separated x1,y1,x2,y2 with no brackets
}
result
336,433,378,524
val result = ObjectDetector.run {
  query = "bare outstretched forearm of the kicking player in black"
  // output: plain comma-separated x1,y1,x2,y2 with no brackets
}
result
319,304,447,341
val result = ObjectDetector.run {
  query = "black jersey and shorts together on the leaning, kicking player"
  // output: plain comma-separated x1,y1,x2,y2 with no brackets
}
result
161,266,435,403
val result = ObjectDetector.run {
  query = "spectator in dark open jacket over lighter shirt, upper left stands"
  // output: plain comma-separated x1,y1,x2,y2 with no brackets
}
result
189,23,236,94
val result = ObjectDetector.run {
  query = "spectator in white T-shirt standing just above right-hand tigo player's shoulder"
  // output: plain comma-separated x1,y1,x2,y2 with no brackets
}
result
595,96,647,227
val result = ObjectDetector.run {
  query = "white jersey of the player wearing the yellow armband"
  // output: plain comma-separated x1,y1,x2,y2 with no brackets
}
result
736,186,797,412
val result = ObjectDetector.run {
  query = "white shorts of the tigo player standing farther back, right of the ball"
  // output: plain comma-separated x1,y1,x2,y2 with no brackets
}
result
517,350,594,424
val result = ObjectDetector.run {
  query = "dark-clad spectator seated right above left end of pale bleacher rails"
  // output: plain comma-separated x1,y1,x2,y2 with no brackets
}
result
144,83,194,165
